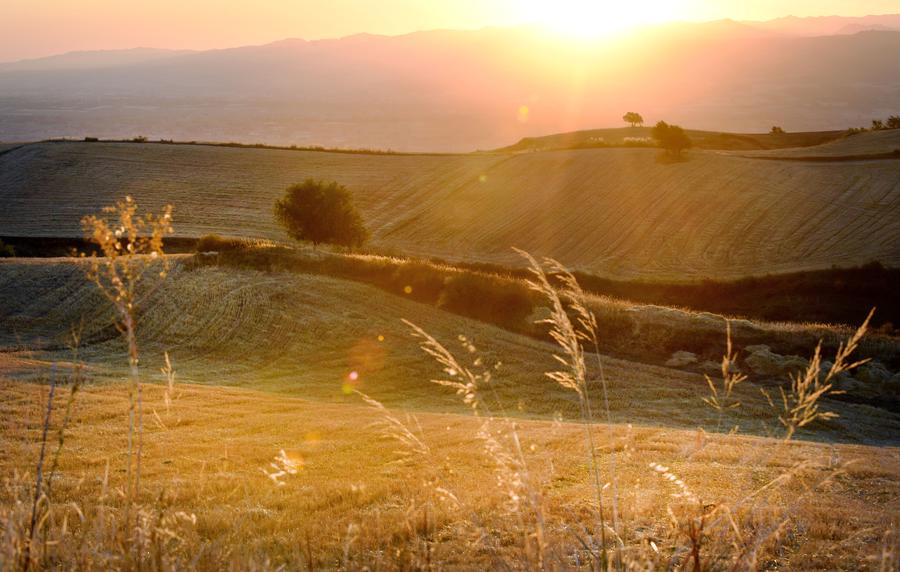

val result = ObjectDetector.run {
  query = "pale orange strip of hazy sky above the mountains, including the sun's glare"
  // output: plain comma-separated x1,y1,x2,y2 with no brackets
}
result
0,0,900,61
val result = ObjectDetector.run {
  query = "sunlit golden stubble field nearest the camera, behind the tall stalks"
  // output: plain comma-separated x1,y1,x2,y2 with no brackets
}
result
0,381,900,570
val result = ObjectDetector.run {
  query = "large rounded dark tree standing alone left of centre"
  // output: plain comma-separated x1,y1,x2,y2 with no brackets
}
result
275,179,369,247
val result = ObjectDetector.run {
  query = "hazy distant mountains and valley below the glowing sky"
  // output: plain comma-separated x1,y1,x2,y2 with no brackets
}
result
0,15,900,151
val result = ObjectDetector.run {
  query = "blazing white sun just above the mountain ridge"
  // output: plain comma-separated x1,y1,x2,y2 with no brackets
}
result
525,0,678,39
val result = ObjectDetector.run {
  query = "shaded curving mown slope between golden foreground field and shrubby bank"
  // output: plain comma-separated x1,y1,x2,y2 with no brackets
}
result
0,260,900,441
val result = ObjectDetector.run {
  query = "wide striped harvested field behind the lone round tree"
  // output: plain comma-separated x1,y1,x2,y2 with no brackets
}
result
0,134,900,279
